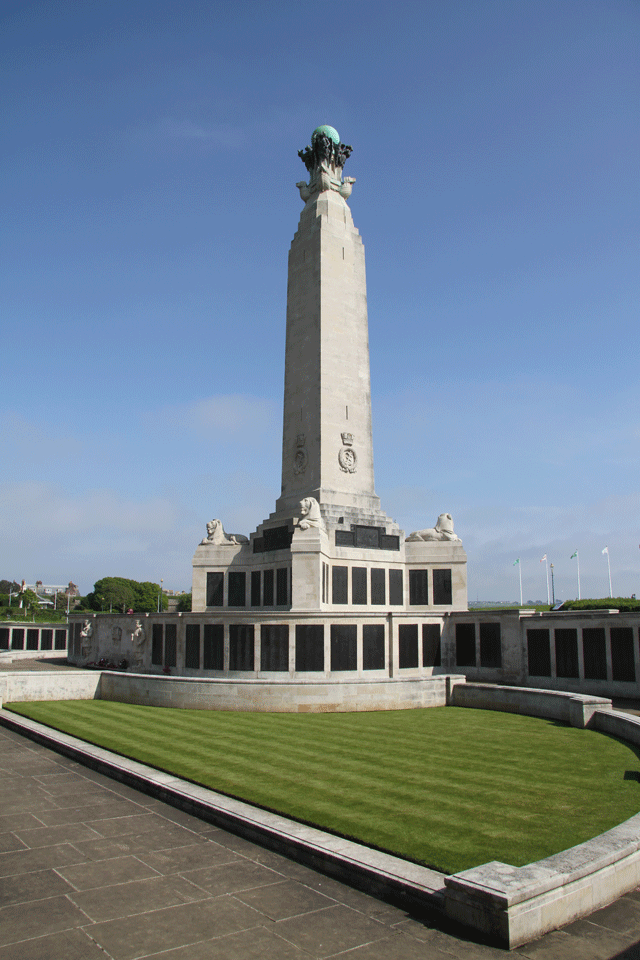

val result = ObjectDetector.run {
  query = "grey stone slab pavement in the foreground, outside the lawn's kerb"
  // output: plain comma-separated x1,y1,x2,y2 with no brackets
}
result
0,664,640,960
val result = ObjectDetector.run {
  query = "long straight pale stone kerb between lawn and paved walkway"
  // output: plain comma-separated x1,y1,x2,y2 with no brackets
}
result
0,707,445,915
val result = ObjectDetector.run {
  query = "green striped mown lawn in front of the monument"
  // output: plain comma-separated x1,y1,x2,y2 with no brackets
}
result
6,700,640,873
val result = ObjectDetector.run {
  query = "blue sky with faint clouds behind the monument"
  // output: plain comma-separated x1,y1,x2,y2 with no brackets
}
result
0,0,640,600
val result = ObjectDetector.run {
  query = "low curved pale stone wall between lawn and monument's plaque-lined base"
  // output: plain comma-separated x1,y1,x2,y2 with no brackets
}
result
100,671,450,713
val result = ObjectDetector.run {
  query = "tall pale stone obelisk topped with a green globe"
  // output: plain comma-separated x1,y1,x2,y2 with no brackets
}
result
275,126,391,525
